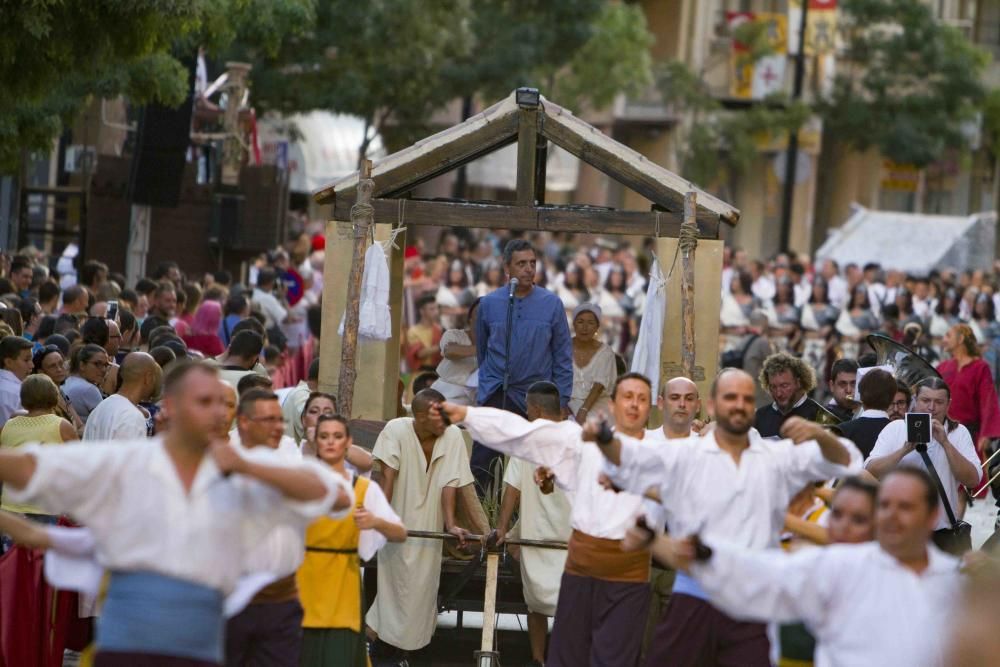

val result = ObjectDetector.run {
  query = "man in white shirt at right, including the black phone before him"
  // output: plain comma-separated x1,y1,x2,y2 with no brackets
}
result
865,377,980,553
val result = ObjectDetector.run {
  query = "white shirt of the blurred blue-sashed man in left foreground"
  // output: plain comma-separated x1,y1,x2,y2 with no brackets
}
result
5,437,354,593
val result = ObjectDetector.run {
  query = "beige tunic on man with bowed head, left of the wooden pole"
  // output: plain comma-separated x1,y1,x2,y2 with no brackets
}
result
365,417,473,651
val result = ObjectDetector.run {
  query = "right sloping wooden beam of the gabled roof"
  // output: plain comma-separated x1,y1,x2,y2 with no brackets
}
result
540,100,740,225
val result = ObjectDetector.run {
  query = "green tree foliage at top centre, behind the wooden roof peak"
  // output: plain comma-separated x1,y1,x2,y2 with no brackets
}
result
243,0,652,154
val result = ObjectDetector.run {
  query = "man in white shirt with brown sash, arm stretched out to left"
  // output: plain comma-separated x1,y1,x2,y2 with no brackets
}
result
439,373,672,667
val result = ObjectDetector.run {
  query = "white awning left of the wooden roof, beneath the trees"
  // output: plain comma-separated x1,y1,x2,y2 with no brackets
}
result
258,111,385,193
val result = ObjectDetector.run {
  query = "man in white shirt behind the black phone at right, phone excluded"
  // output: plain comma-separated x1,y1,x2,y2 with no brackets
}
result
865,377,980,548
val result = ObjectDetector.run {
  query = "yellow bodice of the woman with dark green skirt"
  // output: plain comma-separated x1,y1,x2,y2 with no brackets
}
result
296,477,369,632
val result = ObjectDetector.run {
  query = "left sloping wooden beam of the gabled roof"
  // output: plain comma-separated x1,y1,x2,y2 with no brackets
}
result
313,95,519,204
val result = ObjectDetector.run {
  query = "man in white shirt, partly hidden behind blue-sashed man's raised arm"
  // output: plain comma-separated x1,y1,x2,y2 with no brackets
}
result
226,388,305,667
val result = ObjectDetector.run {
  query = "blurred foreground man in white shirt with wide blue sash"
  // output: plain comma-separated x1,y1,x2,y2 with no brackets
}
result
0,362,354,667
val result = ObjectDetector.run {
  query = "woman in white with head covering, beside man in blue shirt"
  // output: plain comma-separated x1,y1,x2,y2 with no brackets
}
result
569,303,617,424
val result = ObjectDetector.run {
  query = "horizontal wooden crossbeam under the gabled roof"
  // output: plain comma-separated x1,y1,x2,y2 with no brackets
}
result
333,198,719,239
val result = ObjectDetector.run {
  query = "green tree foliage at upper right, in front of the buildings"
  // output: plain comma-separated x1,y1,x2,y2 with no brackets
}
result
657,0,1000,184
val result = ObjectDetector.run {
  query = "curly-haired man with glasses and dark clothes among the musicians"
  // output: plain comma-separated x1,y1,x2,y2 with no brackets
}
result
754,352,820,438
